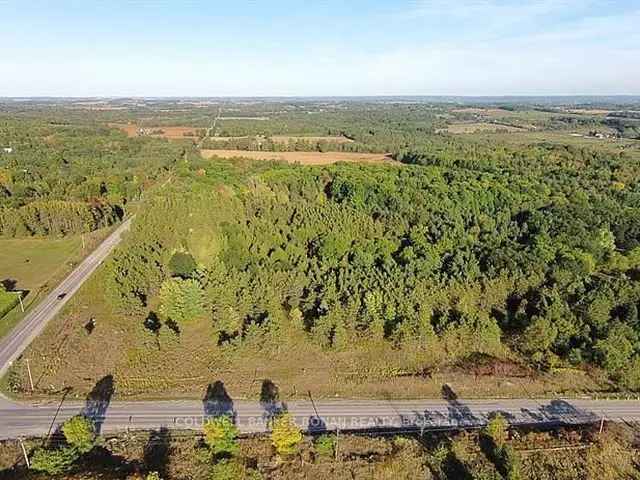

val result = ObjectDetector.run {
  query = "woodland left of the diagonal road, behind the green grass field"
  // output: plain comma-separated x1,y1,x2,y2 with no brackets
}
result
0,118,190,236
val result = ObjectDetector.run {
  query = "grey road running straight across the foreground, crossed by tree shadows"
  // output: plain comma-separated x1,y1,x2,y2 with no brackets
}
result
0,399,640,438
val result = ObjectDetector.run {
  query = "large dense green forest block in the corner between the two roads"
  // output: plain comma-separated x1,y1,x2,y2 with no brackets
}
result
102,146,640,389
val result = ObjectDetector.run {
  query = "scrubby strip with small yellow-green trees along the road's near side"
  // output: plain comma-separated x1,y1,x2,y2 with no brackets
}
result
0,422,640,480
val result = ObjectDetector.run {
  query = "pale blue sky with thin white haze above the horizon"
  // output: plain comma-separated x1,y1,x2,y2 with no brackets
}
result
0,0,640,97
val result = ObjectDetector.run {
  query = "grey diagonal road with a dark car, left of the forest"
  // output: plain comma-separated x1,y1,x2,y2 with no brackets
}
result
0,219,131,377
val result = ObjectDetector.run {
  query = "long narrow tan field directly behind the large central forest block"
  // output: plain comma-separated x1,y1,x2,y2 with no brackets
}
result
201,150,393,165
